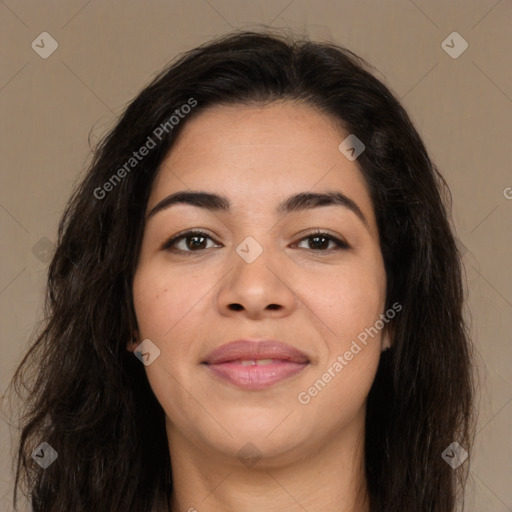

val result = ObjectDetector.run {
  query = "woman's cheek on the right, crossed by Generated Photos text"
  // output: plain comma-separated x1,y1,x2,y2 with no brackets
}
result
298,258,386,414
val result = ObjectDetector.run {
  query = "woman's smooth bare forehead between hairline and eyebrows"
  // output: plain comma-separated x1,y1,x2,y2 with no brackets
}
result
148,101,373,230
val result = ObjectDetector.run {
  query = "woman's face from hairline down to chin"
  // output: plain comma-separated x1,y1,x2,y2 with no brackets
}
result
128,102,388,468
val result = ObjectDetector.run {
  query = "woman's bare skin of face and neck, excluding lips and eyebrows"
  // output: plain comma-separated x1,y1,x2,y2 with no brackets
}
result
127,101,390,512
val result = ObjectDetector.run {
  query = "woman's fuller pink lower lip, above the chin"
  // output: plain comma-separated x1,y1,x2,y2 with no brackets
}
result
206,361,307,390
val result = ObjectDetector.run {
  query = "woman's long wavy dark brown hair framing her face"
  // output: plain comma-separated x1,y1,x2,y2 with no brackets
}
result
5,31,474,512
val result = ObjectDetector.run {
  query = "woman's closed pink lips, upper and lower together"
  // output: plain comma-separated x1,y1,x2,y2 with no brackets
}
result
203,340,310,390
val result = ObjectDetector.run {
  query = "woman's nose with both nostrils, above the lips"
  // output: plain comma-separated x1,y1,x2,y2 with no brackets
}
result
217,244,297,319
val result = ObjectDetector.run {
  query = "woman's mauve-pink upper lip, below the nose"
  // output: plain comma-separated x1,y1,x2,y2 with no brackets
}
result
203,339,309,364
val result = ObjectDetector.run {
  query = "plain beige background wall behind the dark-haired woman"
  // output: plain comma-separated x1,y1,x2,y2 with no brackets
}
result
0,0,512,512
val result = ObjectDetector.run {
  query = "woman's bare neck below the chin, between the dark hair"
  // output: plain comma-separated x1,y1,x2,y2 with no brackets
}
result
167,417,369,512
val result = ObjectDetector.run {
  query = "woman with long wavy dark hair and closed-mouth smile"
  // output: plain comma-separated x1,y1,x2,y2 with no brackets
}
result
6,32,473,512
